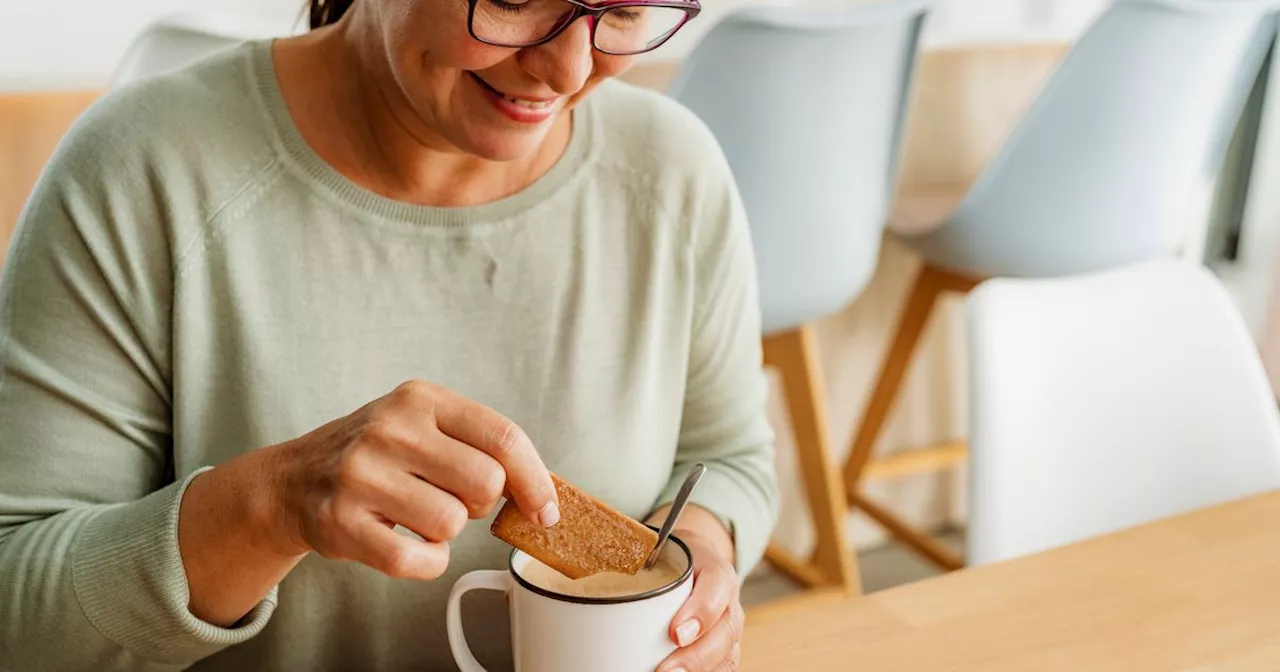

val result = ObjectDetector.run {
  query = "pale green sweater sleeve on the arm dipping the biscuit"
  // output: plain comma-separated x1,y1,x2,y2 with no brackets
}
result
0,91,275,671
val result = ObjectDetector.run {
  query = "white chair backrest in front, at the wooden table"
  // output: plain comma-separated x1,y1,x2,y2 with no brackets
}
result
968,261,1280,564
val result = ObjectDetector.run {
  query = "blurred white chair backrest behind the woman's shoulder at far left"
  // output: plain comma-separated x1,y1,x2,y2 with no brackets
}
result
111,13,294,87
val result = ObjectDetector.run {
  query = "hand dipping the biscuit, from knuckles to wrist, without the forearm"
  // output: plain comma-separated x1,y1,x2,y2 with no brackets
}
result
269,381,559,580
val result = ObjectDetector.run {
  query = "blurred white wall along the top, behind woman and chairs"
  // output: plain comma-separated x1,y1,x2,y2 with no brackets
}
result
0,0,1108,91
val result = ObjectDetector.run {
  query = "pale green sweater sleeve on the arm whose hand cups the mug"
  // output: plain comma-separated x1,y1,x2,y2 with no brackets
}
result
660,132,778,576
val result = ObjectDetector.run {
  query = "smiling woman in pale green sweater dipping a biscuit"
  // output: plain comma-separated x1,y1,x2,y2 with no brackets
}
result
0,0,776,672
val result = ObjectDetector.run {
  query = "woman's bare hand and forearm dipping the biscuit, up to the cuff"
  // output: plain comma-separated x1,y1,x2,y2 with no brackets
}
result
178,383,559,627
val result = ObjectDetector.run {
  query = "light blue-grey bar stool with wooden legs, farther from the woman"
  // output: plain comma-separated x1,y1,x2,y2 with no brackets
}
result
845,0,1275,570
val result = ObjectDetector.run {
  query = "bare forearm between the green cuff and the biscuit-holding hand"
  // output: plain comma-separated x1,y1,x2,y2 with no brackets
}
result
178,448,306,627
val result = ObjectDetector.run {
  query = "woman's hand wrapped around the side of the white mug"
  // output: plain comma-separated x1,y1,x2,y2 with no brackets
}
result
658,525,744,672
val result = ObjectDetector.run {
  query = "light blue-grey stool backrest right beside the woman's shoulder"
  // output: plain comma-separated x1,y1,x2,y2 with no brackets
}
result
669,0,928,333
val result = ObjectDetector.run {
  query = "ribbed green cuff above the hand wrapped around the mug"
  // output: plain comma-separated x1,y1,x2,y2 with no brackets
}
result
658,463,773,577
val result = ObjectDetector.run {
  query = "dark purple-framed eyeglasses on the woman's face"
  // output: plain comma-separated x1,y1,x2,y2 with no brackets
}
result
467,0,701,56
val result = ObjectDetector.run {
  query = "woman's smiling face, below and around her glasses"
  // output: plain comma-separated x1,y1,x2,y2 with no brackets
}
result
366,0,634,161
